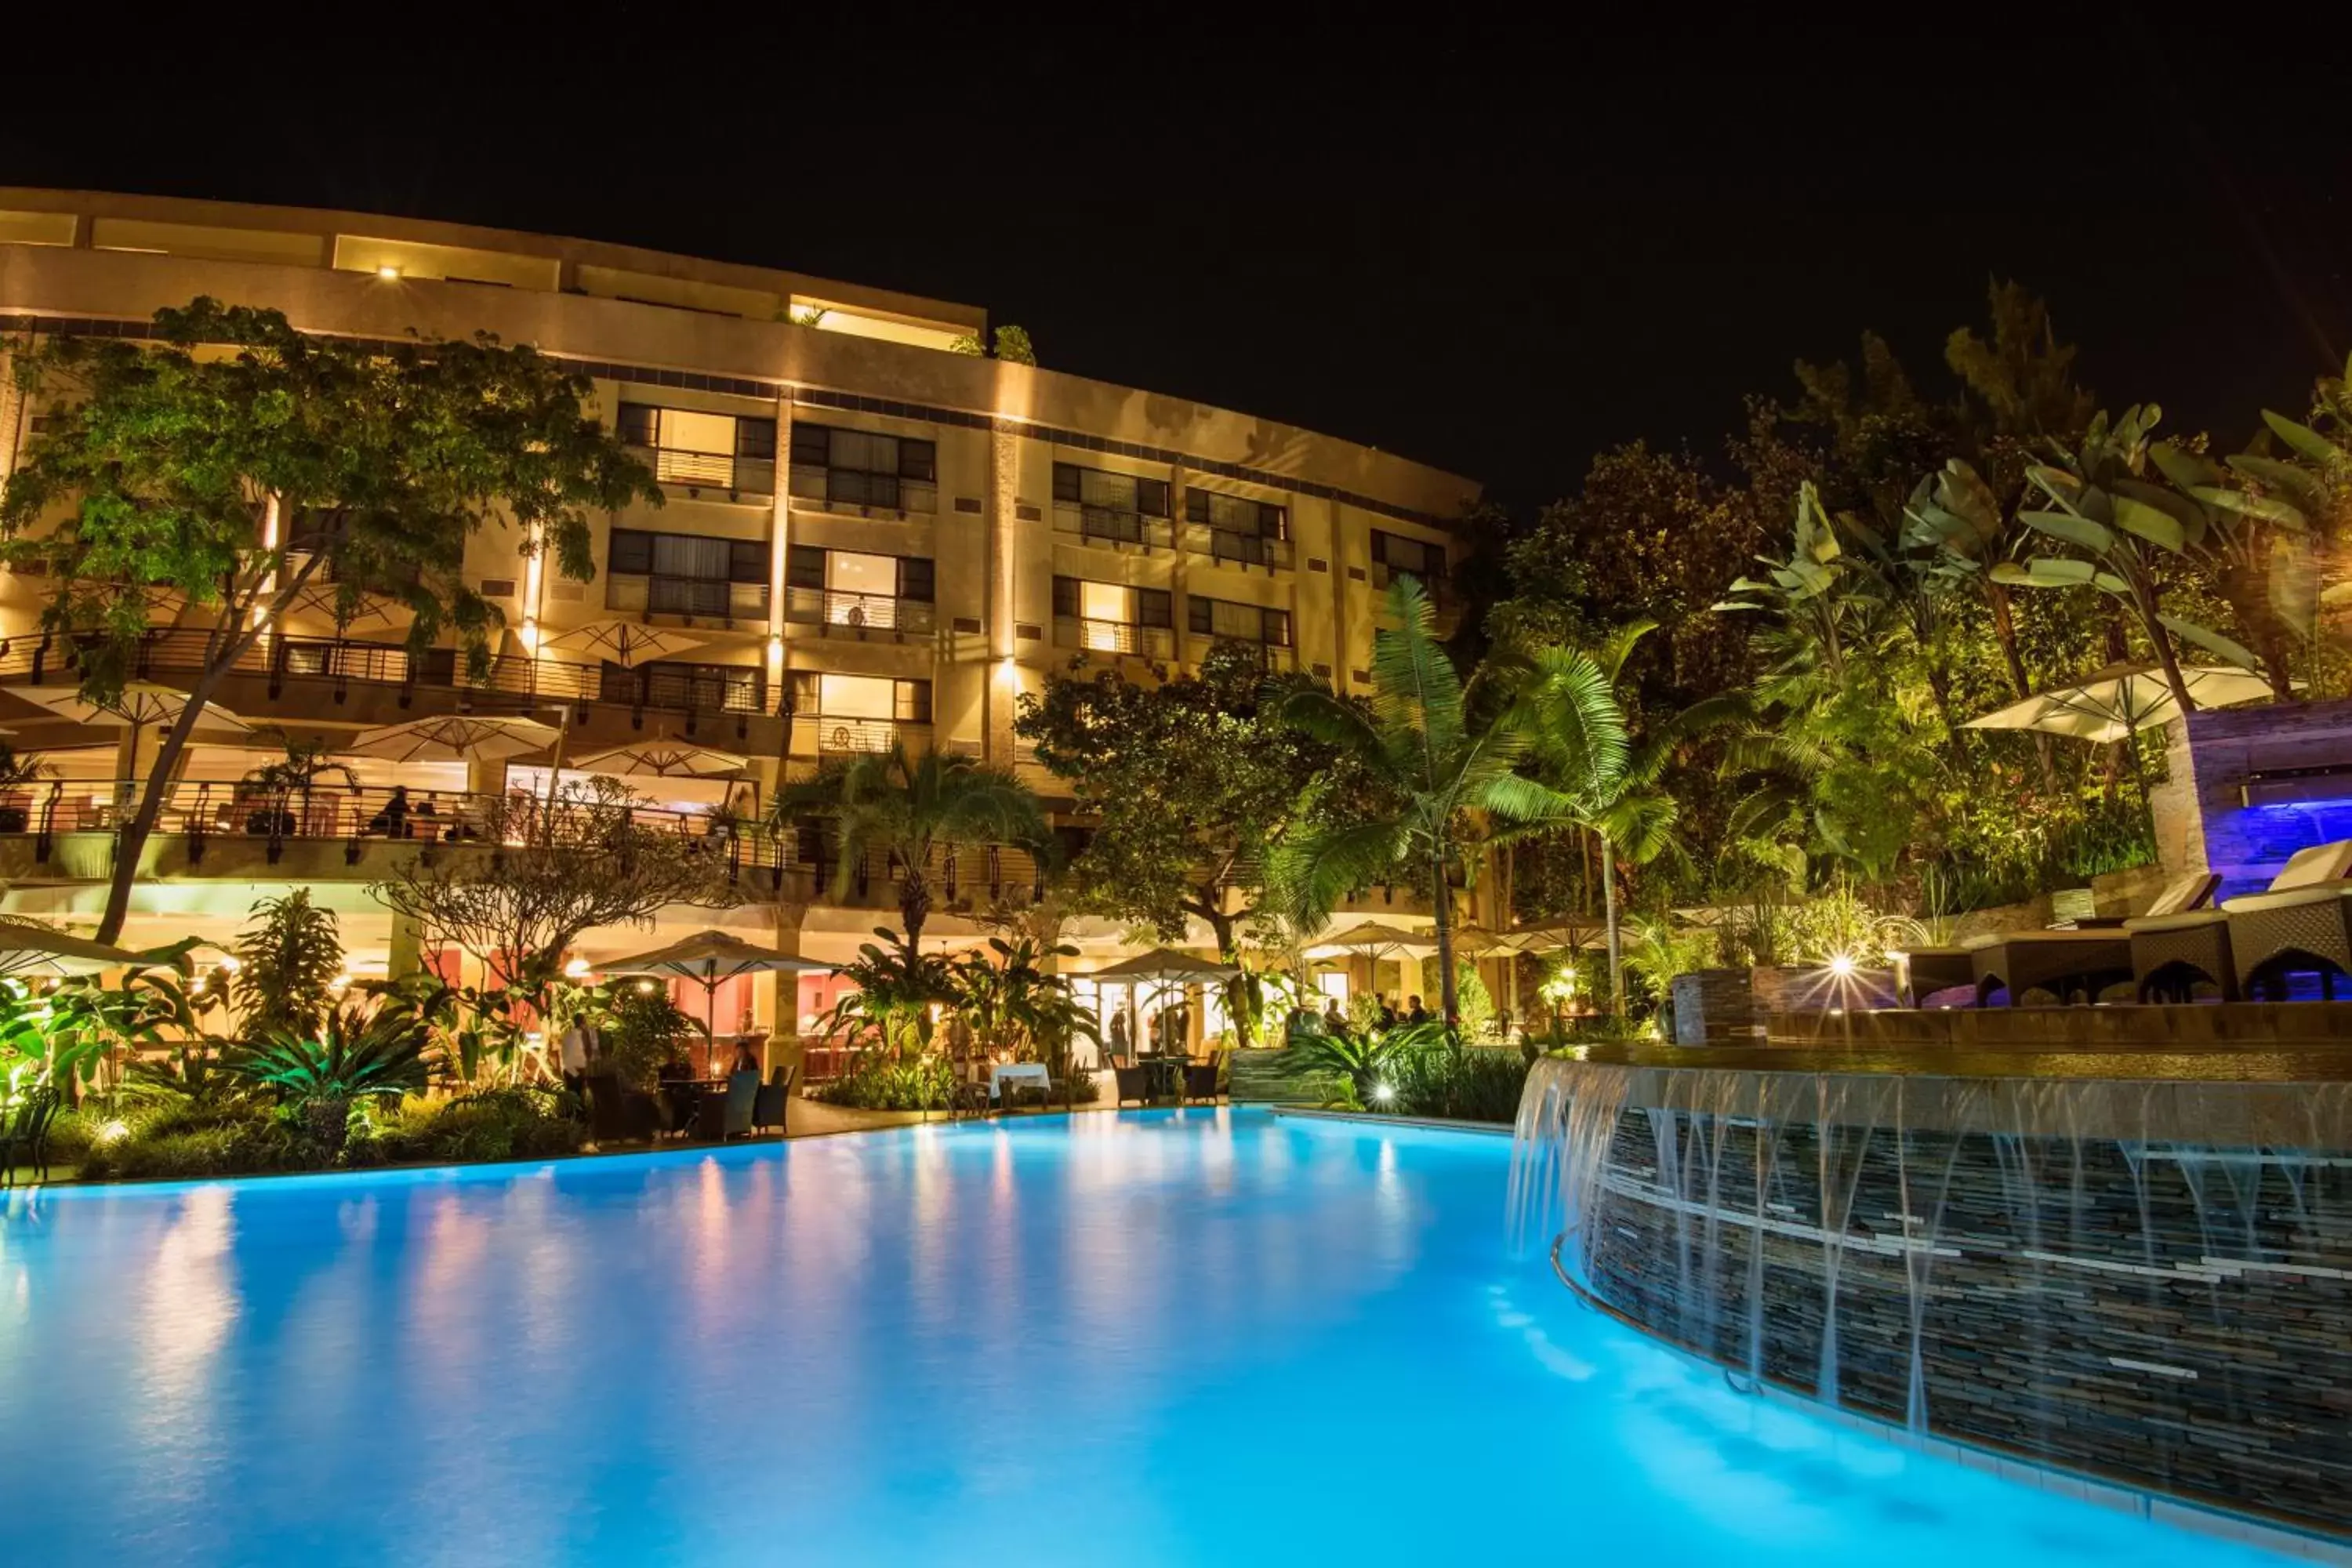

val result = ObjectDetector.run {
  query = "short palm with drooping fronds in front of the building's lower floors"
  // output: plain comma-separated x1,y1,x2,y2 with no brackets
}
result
771,743,1054,949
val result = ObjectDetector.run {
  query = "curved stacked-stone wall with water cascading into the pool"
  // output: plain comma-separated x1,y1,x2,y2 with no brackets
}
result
1515,1053,2352,1535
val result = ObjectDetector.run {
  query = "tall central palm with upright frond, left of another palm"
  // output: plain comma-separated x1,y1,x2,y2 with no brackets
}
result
1265,576,1566,1025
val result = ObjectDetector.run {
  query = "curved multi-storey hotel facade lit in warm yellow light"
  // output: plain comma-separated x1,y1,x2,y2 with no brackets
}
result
0,188,1477,1029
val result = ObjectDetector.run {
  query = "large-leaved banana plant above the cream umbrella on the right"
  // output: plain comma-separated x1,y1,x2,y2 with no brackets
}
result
1992,405,2256,713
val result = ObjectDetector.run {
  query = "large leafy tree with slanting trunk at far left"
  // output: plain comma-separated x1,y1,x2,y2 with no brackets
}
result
0,299,661,942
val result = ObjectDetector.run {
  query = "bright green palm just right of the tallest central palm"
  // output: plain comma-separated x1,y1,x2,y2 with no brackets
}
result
1519,621,1705,1015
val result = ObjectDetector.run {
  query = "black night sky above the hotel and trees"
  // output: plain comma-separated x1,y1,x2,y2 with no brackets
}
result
0,16,2352,508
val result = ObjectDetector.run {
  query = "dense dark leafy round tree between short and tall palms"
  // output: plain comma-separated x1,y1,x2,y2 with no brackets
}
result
1014,644,1336,964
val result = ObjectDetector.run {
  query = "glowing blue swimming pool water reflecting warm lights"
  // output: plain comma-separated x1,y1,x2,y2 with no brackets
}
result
0,1109,2272,1568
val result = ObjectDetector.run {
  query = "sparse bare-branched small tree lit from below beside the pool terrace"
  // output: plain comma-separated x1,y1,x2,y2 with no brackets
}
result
369,779,736,996
